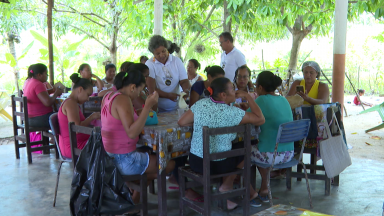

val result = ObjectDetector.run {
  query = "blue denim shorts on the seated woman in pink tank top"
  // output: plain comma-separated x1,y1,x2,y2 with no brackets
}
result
107,151,149,175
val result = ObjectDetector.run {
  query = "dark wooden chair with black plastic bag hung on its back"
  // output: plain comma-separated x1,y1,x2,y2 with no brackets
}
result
68,122,148,216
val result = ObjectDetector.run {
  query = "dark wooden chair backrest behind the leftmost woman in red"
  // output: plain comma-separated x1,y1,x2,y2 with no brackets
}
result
11,95,29,135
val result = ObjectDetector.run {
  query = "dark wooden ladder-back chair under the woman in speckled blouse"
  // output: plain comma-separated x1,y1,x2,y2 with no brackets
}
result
179,125,251,216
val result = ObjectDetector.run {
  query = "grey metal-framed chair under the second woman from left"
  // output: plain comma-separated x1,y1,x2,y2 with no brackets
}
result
49,113,72,207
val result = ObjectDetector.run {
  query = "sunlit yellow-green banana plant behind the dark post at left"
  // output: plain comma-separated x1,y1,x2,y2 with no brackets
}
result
30,30,85,84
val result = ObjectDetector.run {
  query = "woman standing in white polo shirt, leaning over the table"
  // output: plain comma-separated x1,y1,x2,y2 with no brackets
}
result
145,35,191,112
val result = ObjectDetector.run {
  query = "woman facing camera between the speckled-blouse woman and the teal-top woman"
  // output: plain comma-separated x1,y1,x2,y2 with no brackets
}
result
233,65,257,103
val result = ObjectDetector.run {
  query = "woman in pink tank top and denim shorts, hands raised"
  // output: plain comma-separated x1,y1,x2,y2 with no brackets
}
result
101,70,174,203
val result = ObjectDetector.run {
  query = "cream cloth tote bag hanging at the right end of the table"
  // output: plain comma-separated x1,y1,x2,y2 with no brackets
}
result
319,112,352,178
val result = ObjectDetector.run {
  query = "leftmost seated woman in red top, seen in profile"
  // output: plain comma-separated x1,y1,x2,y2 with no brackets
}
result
24,63,63,128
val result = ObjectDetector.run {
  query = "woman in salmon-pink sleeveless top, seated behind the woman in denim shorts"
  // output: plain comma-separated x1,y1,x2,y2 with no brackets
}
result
57,73,100,158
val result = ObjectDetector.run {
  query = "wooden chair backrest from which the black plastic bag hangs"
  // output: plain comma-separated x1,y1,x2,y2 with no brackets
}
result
68,122,101,167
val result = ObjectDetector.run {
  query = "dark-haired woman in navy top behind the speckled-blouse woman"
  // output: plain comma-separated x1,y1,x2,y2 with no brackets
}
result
189,65,225,107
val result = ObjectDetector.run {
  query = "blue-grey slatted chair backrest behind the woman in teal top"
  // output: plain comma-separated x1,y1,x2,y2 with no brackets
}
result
273,119,311,162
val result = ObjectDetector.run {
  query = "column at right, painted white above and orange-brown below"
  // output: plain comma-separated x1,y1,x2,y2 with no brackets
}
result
332,0,348,115
